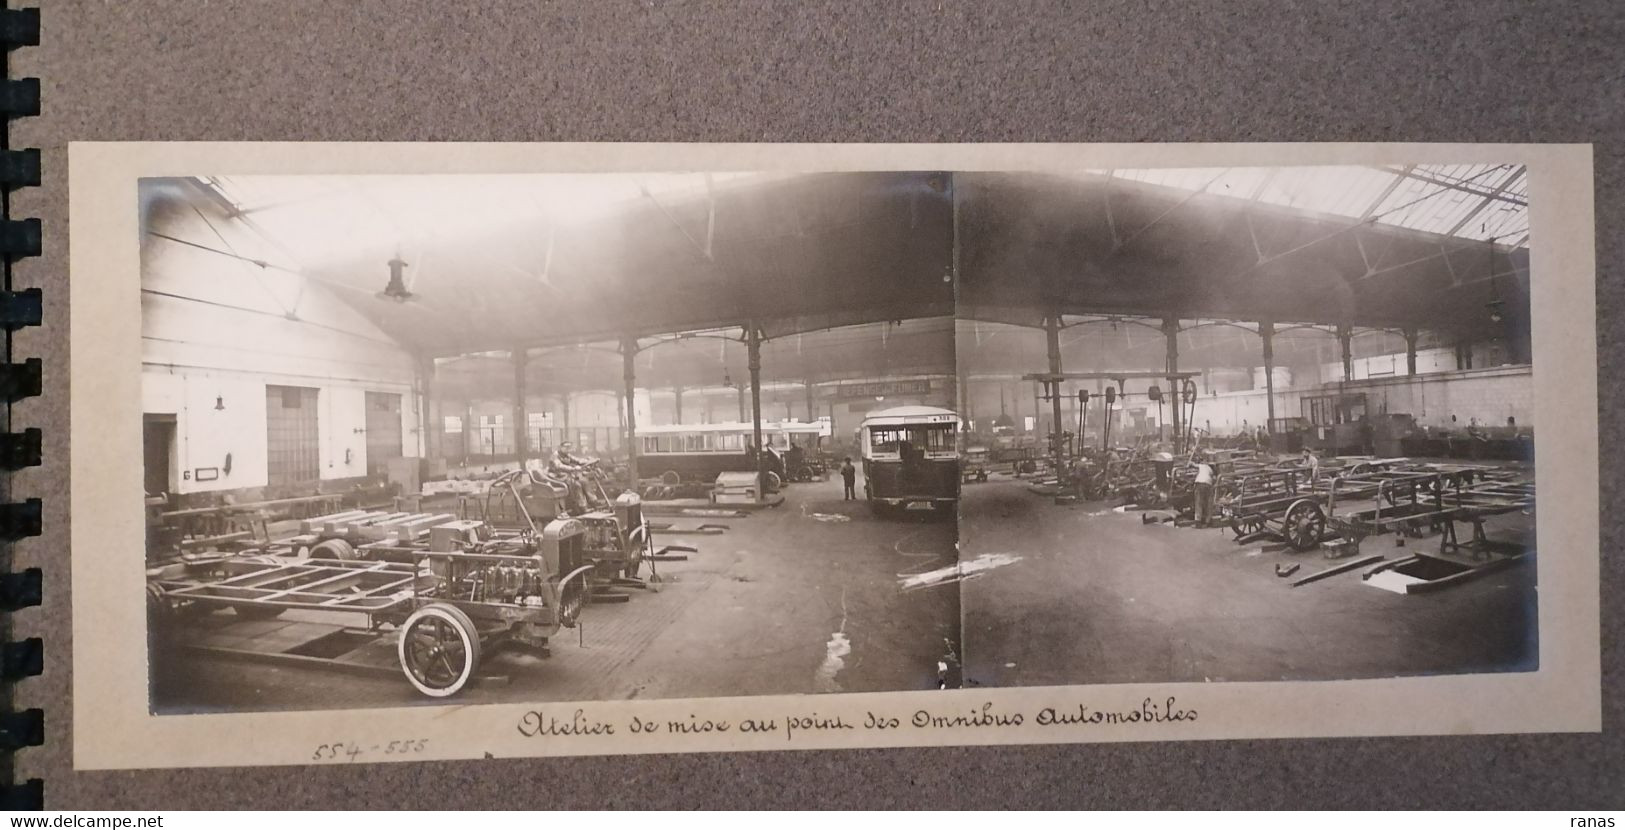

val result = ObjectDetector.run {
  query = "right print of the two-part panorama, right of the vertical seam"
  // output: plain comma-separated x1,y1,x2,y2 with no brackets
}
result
956,164,1539,685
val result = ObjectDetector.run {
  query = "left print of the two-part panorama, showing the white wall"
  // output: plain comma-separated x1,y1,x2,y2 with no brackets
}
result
141,172,962,713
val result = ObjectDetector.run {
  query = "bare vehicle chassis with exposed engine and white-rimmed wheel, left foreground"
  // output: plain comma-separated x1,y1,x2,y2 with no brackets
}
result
146,518,593,697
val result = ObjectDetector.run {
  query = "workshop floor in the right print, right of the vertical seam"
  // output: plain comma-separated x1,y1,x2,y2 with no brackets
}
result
959,478,1537,685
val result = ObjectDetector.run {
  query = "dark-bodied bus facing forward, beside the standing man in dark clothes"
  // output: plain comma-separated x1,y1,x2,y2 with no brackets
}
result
858,406,959,515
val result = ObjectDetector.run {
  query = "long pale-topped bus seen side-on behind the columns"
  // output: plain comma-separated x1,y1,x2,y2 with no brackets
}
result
637,419,830,489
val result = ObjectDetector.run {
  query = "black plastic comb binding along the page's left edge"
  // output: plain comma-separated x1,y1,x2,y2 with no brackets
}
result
0,0,46,811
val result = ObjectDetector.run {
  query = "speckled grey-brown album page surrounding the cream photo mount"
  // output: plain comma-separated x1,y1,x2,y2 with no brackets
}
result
11,0,1625,811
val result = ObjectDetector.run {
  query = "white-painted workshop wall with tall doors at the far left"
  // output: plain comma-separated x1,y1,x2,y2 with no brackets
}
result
141,185,423,494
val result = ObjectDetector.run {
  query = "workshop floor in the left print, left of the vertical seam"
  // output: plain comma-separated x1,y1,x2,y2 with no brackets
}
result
153,479,959,713
